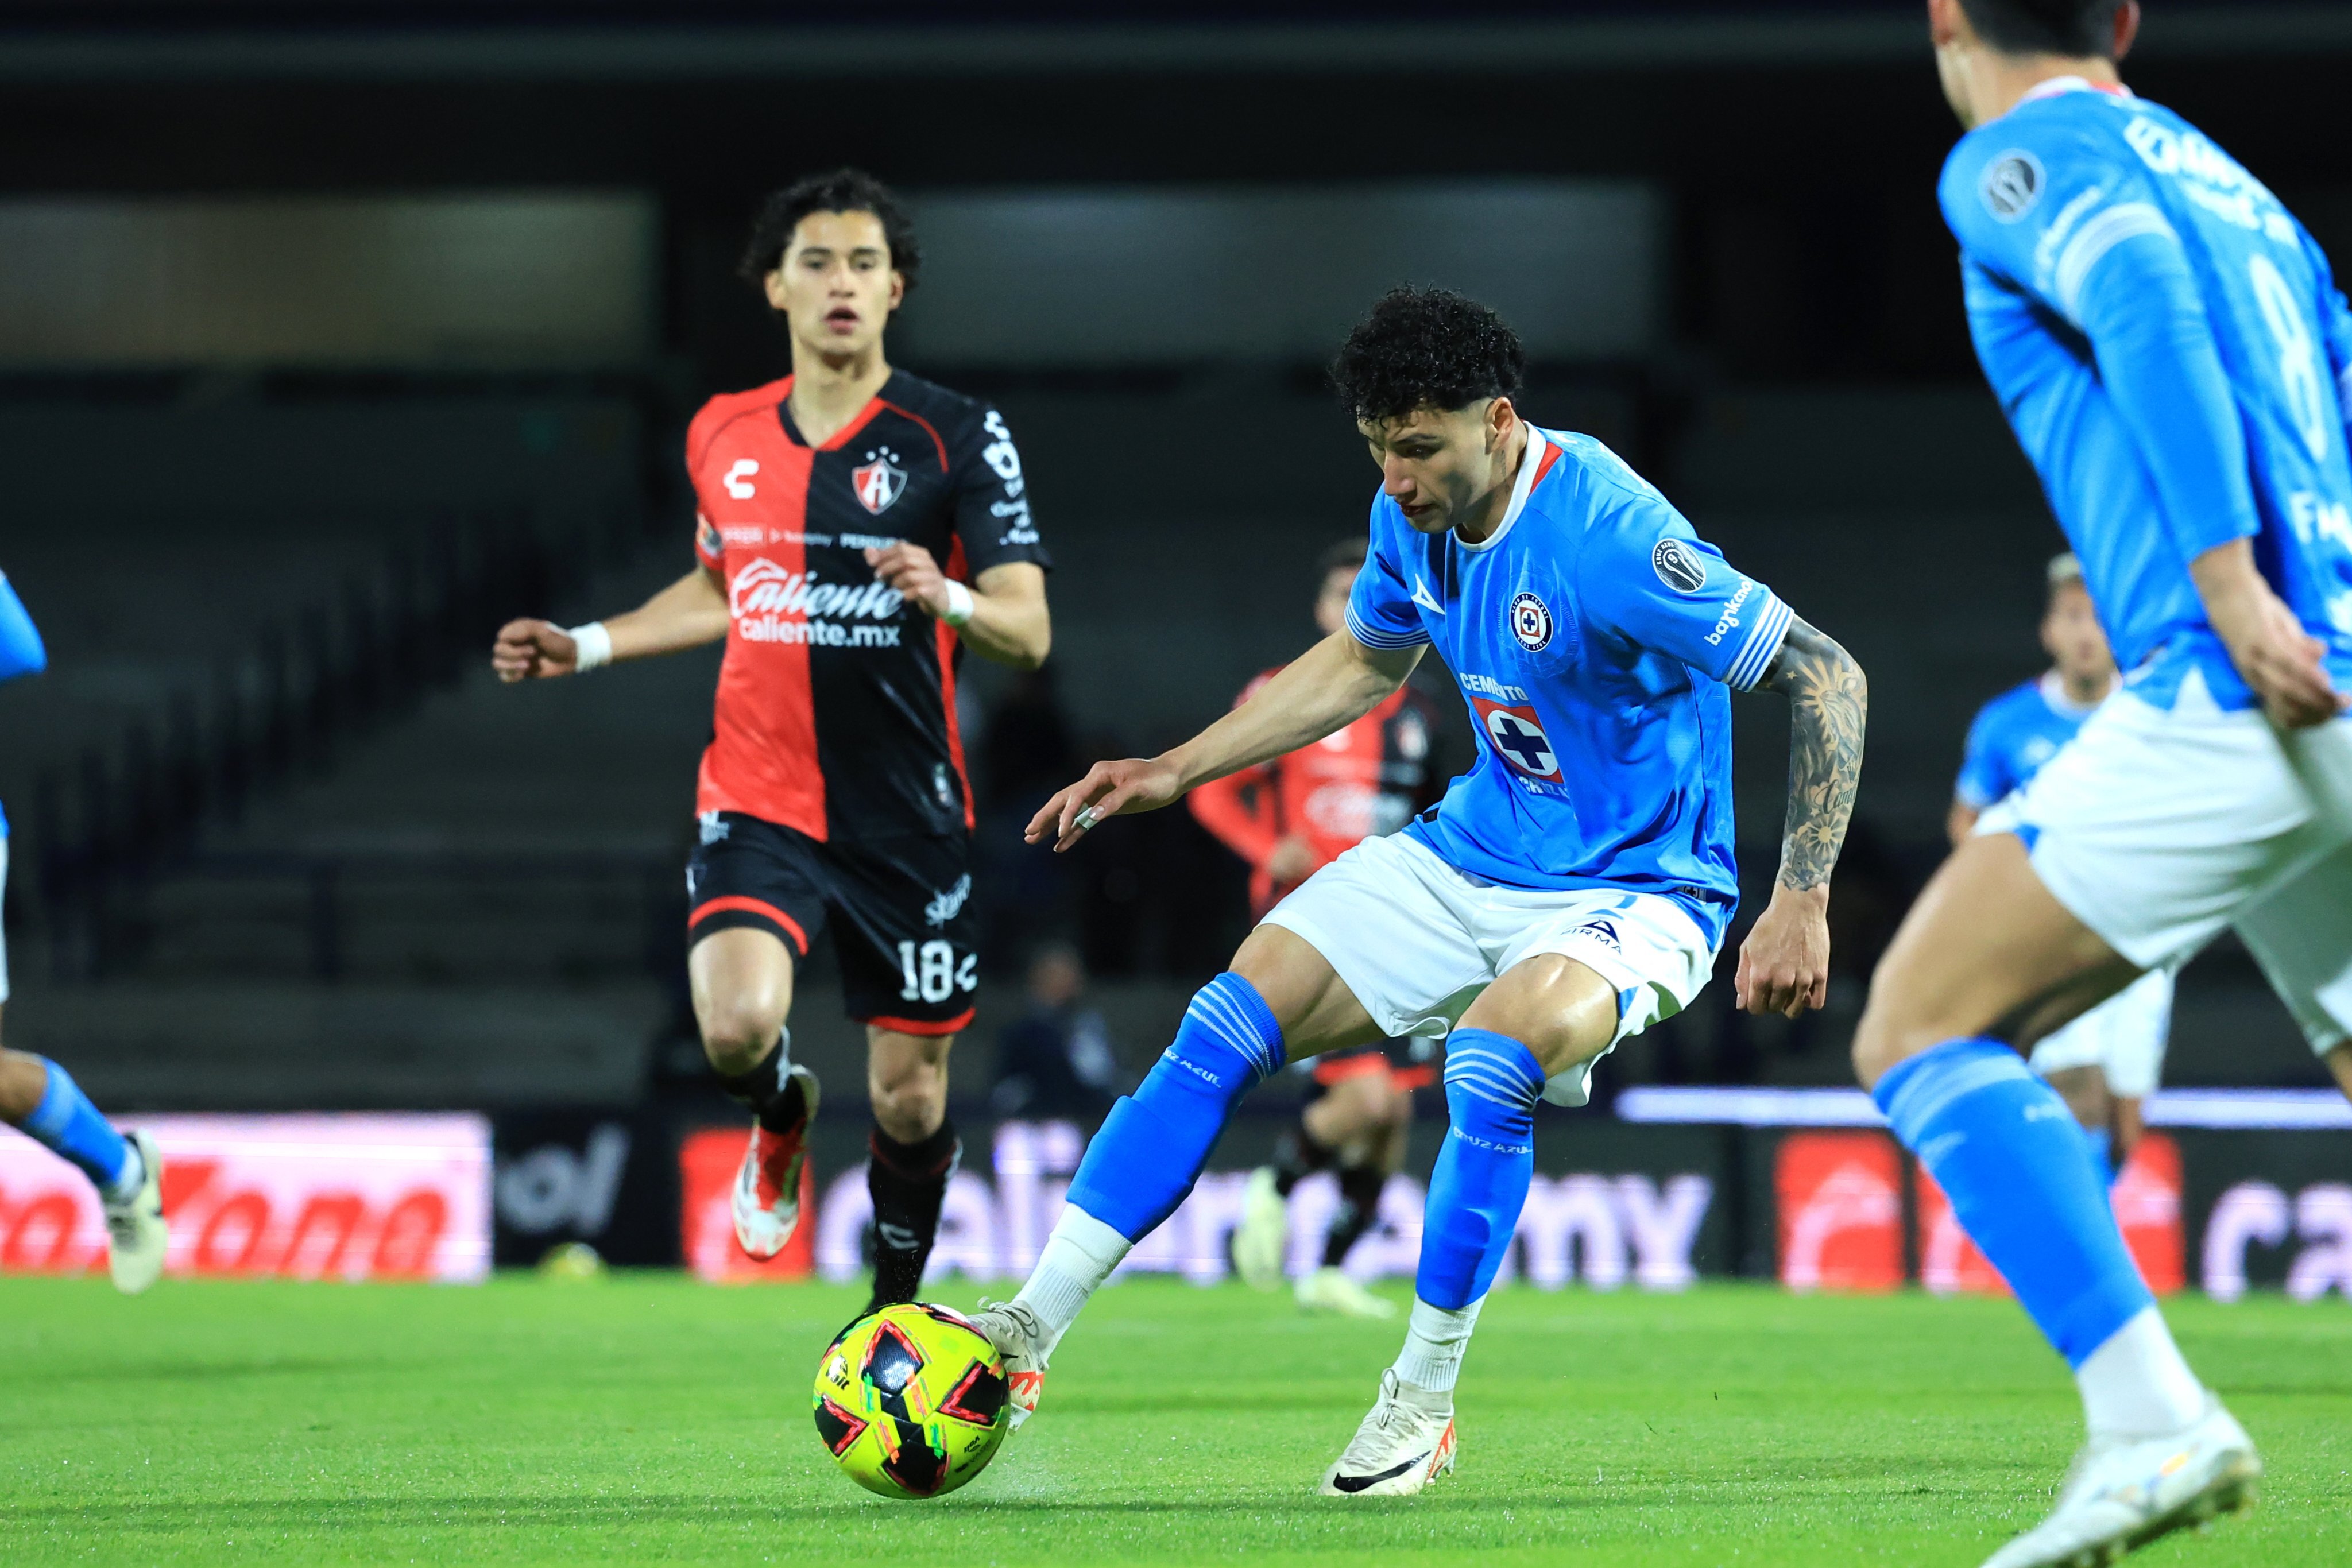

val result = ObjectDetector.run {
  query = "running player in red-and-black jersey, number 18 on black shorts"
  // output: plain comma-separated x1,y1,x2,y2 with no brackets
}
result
492,169,1051,1304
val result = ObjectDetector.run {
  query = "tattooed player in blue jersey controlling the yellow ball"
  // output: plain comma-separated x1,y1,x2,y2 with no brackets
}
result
976,289,1865,1497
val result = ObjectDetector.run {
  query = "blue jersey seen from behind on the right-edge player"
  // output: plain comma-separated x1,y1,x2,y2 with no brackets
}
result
1938,78,2352,707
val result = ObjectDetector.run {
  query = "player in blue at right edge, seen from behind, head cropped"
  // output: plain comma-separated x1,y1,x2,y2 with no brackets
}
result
1854,0,2352,1568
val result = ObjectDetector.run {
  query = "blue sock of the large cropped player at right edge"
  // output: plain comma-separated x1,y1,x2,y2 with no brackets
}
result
1872,1039,2154,1366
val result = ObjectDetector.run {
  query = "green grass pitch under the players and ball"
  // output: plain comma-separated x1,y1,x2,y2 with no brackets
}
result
0,1274,2352,1568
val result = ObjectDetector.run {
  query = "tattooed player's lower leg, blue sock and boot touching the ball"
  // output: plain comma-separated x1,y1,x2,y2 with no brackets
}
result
974,971,1282,1427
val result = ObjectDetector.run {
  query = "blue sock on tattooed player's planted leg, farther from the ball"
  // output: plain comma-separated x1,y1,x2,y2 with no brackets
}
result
1414,1029,1543,1312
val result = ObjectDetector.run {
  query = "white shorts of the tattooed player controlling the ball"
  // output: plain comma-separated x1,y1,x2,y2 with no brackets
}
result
1266,832,1715,1105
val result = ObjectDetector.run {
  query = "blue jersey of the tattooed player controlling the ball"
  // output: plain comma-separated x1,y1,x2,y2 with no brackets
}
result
1348,430,1790,943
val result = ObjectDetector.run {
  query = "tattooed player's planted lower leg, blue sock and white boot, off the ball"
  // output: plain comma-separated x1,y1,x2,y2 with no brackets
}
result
1322,1027,1545,1497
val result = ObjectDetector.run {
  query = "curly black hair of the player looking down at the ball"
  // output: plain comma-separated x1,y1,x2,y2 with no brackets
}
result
1331,287,1526,423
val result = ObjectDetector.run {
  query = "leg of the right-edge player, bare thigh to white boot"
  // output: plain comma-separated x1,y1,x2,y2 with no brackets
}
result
1854,835,2260,1568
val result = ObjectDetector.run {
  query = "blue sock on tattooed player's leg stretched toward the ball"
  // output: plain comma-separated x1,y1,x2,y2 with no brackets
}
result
1070,971,1289,1241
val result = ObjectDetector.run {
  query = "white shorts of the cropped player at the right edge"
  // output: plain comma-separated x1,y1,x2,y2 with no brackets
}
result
1976,677,2352,1051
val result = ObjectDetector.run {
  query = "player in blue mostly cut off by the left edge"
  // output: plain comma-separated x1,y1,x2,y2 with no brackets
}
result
0,574,165,1295
